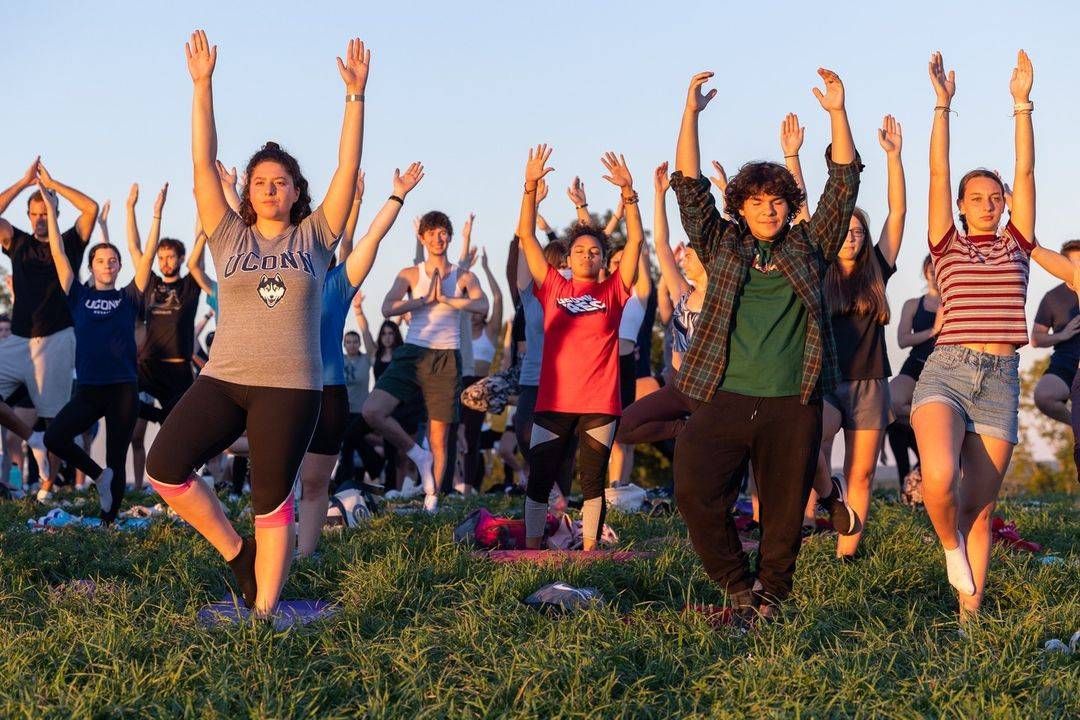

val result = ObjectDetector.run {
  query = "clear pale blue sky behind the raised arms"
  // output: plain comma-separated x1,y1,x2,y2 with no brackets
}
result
0,0,1080,444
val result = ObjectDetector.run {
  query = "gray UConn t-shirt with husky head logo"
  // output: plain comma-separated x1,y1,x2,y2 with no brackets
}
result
203,207,338,390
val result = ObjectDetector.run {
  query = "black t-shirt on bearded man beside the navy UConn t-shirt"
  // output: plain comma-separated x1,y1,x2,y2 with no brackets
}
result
138,274,201,359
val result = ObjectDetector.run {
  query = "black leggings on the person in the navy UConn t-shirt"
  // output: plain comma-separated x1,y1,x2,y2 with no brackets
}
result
45,382,138,521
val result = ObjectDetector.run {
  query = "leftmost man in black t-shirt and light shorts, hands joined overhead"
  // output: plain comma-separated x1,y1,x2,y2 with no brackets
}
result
0,158,97,500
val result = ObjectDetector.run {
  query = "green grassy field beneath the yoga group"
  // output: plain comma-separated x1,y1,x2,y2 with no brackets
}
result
0,487,1080,718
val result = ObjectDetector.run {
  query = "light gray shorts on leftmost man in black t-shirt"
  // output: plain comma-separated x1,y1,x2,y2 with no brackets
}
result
0,327,75,418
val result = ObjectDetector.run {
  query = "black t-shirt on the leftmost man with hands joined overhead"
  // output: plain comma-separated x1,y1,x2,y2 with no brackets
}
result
4,227,86,338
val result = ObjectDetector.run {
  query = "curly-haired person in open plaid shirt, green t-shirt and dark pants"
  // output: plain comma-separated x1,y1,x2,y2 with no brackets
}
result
671,69,861,616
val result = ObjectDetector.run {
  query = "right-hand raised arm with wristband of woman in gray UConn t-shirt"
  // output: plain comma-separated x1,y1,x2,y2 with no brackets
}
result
323,38,372,235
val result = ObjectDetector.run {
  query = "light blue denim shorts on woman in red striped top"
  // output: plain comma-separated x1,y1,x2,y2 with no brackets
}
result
912,345,1020,445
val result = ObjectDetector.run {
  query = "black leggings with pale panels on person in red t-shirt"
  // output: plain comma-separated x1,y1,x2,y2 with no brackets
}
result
525,411,619,542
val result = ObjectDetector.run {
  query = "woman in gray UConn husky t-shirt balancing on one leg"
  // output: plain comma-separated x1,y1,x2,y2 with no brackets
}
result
146,30,370,616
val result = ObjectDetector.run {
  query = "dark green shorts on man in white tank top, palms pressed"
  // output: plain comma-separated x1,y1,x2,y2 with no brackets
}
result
375,343,461,422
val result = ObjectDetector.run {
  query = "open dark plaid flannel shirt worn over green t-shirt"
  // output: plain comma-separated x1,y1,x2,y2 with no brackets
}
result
672,146,862,405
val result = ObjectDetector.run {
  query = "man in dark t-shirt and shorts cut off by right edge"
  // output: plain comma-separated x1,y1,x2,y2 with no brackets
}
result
1031,240,1080,423
